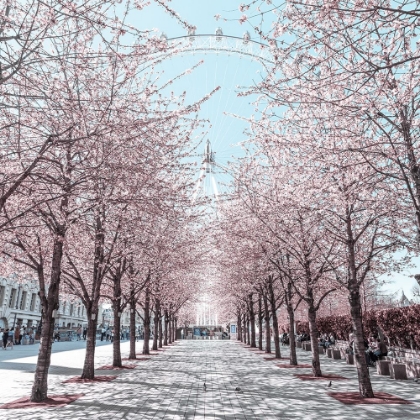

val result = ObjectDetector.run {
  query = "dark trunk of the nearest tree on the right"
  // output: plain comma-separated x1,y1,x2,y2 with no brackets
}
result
349,290,374,398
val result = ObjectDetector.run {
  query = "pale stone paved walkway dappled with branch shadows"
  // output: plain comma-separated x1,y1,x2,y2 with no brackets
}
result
0,340,420,420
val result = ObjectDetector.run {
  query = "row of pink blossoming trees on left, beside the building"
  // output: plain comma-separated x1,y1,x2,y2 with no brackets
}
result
0,0,208,402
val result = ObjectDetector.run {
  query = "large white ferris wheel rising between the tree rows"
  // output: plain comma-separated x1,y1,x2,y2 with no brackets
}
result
152,28,276,209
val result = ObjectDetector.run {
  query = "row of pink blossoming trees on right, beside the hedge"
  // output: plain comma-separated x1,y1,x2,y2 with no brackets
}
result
213,0,420,397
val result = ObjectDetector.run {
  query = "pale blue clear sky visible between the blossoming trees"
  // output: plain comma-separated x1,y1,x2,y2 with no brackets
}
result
119,0,420,298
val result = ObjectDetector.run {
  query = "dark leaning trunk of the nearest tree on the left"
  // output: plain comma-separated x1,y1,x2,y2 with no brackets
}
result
31,231,65,402
